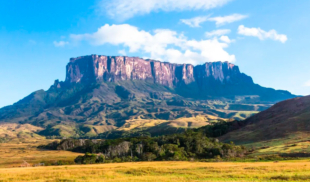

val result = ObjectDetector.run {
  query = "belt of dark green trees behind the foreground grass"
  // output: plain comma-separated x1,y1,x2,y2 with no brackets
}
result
49,130,246,164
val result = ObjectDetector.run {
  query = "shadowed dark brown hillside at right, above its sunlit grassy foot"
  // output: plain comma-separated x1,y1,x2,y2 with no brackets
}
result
220,96,310,144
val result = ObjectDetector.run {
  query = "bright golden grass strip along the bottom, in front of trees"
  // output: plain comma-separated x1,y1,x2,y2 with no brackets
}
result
0,160,310,182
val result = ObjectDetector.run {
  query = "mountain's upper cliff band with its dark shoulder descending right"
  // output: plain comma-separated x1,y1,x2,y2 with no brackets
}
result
60,55,294,102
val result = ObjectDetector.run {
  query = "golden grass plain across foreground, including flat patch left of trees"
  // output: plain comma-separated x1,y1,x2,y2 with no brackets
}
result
0,139,310,182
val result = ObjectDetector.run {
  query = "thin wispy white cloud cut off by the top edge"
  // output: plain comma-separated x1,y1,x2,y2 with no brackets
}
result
99,0,231,20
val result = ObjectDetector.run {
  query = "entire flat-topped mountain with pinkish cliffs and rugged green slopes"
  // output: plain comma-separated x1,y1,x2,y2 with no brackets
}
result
0,55,295,136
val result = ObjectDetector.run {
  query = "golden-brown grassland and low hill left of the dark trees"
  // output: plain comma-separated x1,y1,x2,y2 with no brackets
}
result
0,123,81,167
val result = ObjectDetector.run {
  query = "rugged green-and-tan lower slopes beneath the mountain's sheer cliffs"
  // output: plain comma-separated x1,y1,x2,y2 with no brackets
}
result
0,81,272,137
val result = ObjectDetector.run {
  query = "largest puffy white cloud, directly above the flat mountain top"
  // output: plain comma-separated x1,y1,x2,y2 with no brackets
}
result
70,24,235,64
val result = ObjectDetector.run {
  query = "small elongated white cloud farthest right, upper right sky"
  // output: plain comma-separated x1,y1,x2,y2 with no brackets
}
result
238,25,287,43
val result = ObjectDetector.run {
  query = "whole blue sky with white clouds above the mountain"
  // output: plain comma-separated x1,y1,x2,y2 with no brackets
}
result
0,0,310,107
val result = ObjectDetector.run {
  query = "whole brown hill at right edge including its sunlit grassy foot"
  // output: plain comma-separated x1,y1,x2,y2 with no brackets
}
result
220,96,310,154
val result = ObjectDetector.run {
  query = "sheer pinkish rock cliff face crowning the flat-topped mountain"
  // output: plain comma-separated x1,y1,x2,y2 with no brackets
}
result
66,55,253,87
